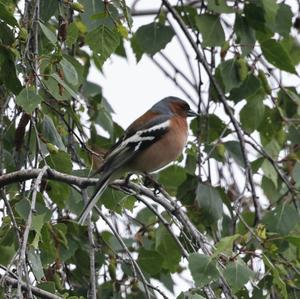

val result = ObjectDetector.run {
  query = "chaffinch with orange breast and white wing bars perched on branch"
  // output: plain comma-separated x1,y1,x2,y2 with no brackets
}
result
78,97,198,224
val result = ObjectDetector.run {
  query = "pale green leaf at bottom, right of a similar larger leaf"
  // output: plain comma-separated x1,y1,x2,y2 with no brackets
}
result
224,258,255,292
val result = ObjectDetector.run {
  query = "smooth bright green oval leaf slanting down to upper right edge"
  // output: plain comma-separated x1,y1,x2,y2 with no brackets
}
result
260,39,297,74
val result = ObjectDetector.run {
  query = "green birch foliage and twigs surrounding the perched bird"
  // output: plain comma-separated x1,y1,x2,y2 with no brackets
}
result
0,0,300,299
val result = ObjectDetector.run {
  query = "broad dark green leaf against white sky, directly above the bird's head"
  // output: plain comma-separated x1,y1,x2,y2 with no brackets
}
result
134,22,174,55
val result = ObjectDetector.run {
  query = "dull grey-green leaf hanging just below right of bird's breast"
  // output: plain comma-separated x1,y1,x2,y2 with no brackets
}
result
196,183,223,224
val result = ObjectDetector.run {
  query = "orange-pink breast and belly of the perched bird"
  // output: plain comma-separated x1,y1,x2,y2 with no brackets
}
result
129,117,188,172
